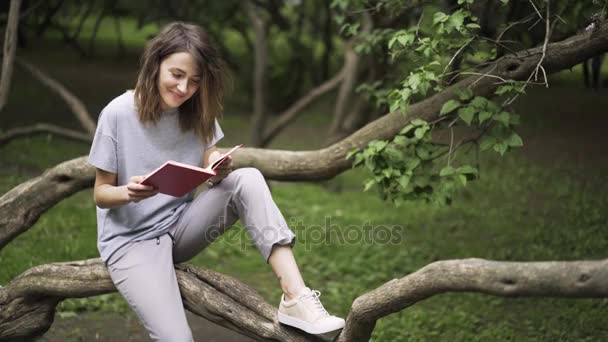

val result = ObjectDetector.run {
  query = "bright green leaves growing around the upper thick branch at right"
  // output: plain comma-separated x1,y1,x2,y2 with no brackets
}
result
334,0,536,206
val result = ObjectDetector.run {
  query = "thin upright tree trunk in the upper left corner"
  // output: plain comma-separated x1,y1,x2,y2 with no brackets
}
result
0,0,21,112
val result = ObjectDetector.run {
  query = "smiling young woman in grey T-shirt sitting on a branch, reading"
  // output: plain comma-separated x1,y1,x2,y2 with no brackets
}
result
89,22,344,342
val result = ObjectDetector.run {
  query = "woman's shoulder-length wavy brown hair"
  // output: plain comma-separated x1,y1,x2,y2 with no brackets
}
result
135,22,225,143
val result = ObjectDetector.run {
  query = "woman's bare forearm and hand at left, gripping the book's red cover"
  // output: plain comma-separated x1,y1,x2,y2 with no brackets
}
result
93,168,158,208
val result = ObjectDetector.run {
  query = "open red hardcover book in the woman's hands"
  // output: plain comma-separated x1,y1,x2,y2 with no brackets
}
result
139,144,243,197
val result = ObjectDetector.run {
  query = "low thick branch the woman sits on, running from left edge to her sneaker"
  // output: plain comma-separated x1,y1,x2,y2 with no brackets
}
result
0,259,322,341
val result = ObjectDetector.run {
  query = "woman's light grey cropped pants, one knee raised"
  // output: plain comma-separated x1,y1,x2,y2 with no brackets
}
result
108,168,295,342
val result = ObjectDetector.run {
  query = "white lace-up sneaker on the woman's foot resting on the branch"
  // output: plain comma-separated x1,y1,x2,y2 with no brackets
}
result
279,287,344,335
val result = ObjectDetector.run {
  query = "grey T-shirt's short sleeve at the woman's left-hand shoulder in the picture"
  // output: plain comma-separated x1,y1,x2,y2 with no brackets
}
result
88,111,118,173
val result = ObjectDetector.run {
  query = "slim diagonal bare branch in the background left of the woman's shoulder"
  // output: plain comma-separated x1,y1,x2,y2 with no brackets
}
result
17,60,97,137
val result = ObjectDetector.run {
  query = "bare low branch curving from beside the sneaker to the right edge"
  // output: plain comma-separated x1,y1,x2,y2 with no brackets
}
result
338,259,608,342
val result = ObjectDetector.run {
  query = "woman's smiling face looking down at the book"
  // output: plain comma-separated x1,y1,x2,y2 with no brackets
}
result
158,52,201,110
